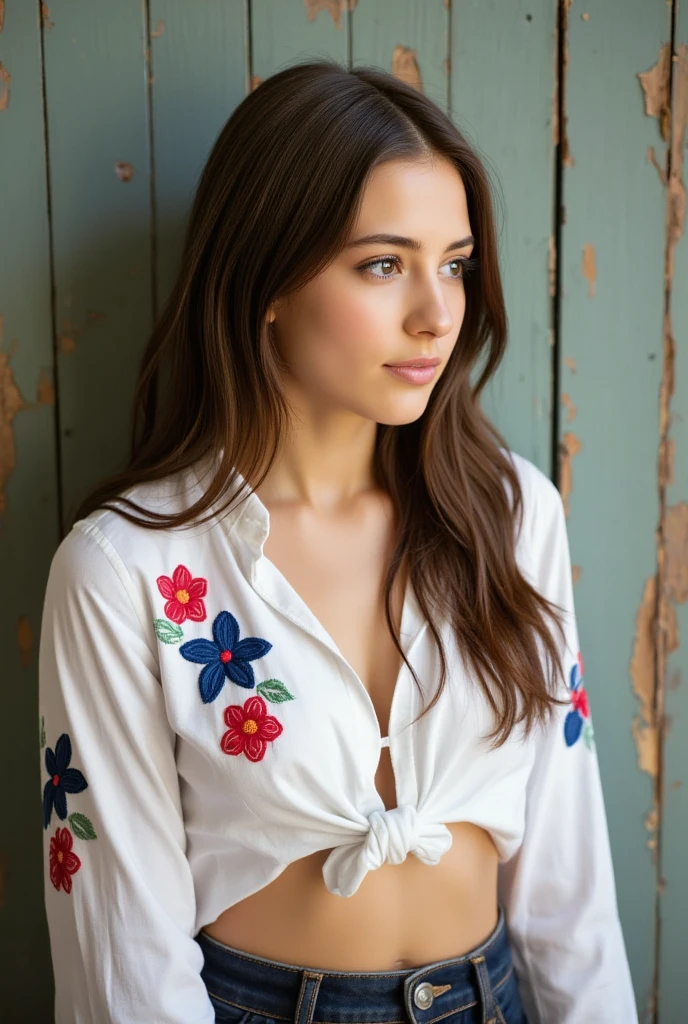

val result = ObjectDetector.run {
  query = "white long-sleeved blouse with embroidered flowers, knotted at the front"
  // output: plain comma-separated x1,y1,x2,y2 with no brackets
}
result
39,453,638,1024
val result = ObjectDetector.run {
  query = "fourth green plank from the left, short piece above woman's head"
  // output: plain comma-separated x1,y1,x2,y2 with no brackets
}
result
251,0,349,84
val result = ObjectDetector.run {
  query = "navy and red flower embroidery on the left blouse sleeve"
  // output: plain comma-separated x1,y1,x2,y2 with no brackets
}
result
40,729,97,893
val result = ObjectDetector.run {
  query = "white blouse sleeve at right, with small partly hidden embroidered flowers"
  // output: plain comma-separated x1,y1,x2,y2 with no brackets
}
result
500,474,638,1024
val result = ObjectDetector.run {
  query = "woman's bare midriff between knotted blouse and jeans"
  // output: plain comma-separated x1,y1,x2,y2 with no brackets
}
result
203,822,499,971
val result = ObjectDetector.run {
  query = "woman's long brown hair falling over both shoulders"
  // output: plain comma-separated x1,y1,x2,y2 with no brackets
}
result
75,59,564,745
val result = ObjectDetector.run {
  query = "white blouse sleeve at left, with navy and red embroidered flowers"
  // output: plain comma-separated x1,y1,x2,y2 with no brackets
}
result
39,520,215,1024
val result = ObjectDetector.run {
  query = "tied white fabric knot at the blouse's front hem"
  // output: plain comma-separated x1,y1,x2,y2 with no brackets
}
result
323,804,454,896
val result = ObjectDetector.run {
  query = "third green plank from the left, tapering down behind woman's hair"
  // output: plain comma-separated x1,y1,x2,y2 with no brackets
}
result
151,0,249,310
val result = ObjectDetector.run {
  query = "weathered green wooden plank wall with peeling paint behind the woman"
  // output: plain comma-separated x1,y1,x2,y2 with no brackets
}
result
0,0,688,1024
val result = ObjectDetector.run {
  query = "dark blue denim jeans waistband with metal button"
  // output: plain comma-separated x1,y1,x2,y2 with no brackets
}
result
196,907,527,1024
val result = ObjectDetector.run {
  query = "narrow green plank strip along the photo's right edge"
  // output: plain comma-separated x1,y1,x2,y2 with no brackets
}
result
657,3,688,1024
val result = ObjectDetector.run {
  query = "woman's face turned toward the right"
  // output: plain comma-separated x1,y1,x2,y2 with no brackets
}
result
274,153,473,425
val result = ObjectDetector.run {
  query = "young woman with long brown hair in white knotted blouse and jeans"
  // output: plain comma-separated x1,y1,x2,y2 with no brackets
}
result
40,60,637,1024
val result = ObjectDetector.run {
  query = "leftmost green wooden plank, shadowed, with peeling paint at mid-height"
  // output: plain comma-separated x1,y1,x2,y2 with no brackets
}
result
0,3,59,1022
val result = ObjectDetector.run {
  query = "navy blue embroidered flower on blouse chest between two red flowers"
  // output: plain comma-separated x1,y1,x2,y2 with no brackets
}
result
179,611,272,703
